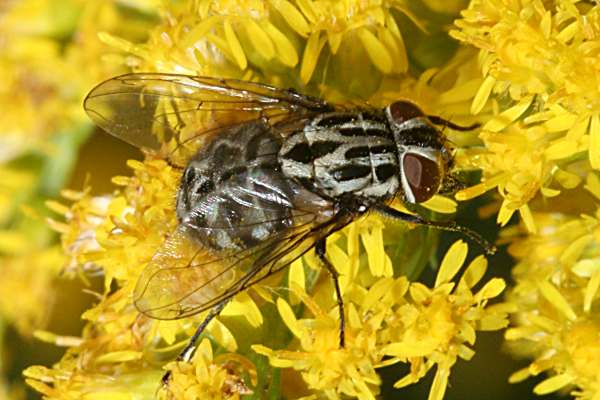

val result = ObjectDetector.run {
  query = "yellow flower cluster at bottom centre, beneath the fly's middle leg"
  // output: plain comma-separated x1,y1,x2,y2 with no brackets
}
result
252,241,508,400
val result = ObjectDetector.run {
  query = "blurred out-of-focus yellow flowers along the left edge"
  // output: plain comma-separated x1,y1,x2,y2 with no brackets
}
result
0,0,156,398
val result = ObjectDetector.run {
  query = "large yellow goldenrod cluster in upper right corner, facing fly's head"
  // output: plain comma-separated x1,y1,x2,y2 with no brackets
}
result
451,0,600,232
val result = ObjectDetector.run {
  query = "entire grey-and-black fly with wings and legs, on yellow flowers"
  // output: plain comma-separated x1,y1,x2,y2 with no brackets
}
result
84,73,493,378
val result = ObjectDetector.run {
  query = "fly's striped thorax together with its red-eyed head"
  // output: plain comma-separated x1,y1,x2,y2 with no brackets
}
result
278,102,450,203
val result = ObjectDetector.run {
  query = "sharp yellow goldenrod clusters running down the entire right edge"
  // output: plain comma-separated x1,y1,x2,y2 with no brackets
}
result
451,1,600,399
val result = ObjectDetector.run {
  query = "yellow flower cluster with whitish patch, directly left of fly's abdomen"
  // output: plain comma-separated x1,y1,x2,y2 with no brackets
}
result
48,160,179,290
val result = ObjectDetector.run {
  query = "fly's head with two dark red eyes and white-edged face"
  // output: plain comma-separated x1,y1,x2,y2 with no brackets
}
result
384,101,468,204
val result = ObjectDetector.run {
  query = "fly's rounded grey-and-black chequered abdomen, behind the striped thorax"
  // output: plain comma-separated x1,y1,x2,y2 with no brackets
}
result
177,122,327,251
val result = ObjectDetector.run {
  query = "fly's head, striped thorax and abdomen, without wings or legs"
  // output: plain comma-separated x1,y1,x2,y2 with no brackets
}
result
177,102,451,250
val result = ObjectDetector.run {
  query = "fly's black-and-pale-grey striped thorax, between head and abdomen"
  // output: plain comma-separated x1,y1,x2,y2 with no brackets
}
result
278,112,400,200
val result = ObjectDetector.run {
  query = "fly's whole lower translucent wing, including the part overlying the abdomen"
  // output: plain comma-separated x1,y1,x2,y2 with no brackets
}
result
134,169,351,319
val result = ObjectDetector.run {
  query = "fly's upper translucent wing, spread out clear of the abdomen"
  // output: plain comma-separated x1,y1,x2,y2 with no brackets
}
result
84,73,331,163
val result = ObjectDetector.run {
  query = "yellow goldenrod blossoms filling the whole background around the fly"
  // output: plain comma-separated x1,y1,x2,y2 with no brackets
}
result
0,0,600,400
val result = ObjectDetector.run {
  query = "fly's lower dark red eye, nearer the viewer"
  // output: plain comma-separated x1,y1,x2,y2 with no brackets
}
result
402,153,441,203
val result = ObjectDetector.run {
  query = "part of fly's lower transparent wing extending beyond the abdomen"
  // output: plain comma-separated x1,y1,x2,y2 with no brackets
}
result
134,206,351,319
